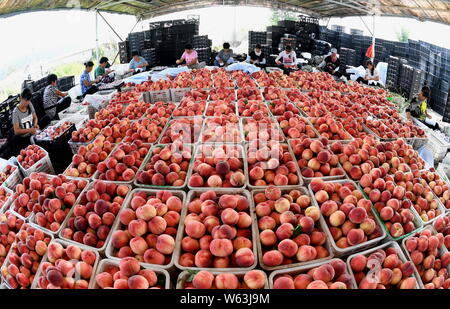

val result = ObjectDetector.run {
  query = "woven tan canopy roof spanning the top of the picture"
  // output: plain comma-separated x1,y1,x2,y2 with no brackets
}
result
0,0,450,24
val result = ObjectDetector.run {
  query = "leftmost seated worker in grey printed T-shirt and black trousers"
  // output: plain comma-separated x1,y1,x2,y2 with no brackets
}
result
0,88,39,159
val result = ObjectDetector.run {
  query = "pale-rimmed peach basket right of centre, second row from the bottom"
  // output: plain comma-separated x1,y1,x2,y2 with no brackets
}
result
308,180,386,257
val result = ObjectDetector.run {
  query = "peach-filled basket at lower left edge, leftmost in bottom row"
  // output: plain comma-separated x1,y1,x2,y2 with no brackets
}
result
1,223,53,289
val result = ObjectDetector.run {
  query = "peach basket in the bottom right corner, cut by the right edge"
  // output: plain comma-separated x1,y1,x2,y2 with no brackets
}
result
402,225,450,289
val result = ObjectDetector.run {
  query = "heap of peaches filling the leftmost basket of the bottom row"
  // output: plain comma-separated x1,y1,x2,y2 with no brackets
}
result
1,223,51,289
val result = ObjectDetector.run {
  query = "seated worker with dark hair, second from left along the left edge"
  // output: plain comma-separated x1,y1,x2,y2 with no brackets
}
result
43,74,72,120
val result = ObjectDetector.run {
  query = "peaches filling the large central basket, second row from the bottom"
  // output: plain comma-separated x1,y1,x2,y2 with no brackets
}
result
177,191,256,268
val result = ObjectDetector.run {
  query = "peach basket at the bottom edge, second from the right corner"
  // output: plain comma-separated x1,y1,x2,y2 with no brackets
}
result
347,241,421,289
